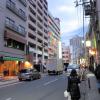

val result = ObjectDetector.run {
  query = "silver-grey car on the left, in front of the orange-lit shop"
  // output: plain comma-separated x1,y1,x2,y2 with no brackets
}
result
18,69,41,81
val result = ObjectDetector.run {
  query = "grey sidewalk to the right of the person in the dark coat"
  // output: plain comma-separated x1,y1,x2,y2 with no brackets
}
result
80,71,100,100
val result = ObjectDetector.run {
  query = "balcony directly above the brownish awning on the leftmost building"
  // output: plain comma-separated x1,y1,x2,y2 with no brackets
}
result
5,22,26,37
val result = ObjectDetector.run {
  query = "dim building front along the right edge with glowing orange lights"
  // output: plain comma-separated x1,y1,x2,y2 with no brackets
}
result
84,0,100,68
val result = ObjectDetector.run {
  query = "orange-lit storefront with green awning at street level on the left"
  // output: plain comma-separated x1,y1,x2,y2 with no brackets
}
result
0,57,24,76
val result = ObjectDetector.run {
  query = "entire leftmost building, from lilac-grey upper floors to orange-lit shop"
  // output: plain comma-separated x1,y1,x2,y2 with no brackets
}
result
0,0,27,75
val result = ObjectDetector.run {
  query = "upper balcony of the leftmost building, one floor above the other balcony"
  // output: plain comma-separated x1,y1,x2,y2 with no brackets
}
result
6,0,27,21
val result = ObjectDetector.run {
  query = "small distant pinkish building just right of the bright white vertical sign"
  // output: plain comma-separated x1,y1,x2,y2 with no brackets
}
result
62,43,71,65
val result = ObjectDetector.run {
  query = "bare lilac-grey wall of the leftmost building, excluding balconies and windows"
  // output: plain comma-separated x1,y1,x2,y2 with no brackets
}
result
0,0,26,58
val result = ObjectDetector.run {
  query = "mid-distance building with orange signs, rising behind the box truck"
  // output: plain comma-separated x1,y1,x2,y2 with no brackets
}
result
48,13,61,58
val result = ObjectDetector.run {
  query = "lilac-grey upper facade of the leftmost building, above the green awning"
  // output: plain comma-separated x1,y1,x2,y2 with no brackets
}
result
0,0,27,59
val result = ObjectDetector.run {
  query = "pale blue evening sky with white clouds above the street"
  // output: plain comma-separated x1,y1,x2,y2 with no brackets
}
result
47,0,88,45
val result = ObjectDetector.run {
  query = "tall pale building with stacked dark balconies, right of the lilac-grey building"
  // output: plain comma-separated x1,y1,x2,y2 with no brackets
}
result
27,0,48,63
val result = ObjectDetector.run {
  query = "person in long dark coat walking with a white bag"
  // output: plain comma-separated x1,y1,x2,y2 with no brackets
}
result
67,69,80,100
